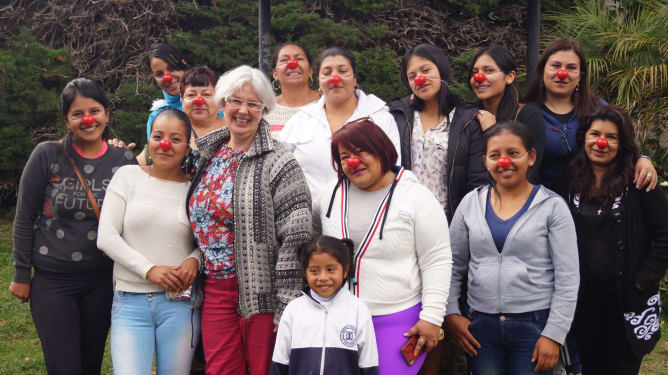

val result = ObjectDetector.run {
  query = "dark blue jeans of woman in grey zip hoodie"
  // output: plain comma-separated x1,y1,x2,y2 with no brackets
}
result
469,309,552,375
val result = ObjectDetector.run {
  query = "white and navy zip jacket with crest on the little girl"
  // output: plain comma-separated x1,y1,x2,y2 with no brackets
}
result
269,287,378,375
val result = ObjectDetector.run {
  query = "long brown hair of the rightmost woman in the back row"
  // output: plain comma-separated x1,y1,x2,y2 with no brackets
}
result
523,39,599,124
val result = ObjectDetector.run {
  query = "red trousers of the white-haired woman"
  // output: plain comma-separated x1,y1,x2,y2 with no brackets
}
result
202,278,276,375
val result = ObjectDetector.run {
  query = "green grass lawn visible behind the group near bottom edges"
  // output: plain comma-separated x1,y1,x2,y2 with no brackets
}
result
0,219,668,375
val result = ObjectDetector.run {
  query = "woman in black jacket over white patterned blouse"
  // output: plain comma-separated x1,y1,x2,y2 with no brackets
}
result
390,44,487,220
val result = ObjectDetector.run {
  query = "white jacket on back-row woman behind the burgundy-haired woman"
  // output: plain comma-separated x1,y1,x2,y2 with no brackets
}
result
279,90,401,197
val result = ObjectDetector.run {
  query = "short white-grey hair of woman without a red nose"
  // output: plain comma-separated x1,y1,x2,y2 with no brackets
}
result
214,65,276,115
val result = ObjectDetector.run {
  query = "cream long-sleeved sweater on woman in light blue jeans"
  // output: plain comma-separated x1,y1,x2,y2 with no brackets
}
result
97,165,201,293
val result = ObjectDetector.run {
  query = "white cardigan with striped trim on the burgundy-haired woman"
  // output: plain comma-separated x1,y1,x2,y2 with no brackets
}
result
313,167,452,326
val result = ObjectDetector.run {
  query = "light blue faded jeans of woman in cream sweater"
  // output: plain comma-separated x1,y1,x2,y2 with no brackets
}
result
111,291,200,375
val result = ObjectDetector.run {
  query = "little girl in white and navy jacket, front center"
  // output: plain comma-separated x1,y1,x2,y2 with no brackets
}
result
270,236,378,375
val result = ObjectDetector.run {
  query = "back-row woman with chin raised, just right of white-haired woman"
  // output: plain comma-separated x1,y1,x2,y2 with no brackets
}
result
265,42,320,139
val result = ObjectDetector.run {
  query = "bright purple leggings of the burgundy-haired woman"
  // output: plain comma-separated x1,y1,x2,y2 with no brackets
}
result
371,303,425,375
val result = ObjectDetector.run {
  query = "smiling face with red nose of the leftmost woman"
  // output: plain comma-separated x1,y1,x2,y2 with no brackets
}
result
65,94,109,144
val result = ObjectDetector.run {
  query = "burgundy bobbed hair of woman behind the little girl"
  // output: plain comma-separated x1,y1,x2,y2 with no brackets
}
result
331,117,398,179
